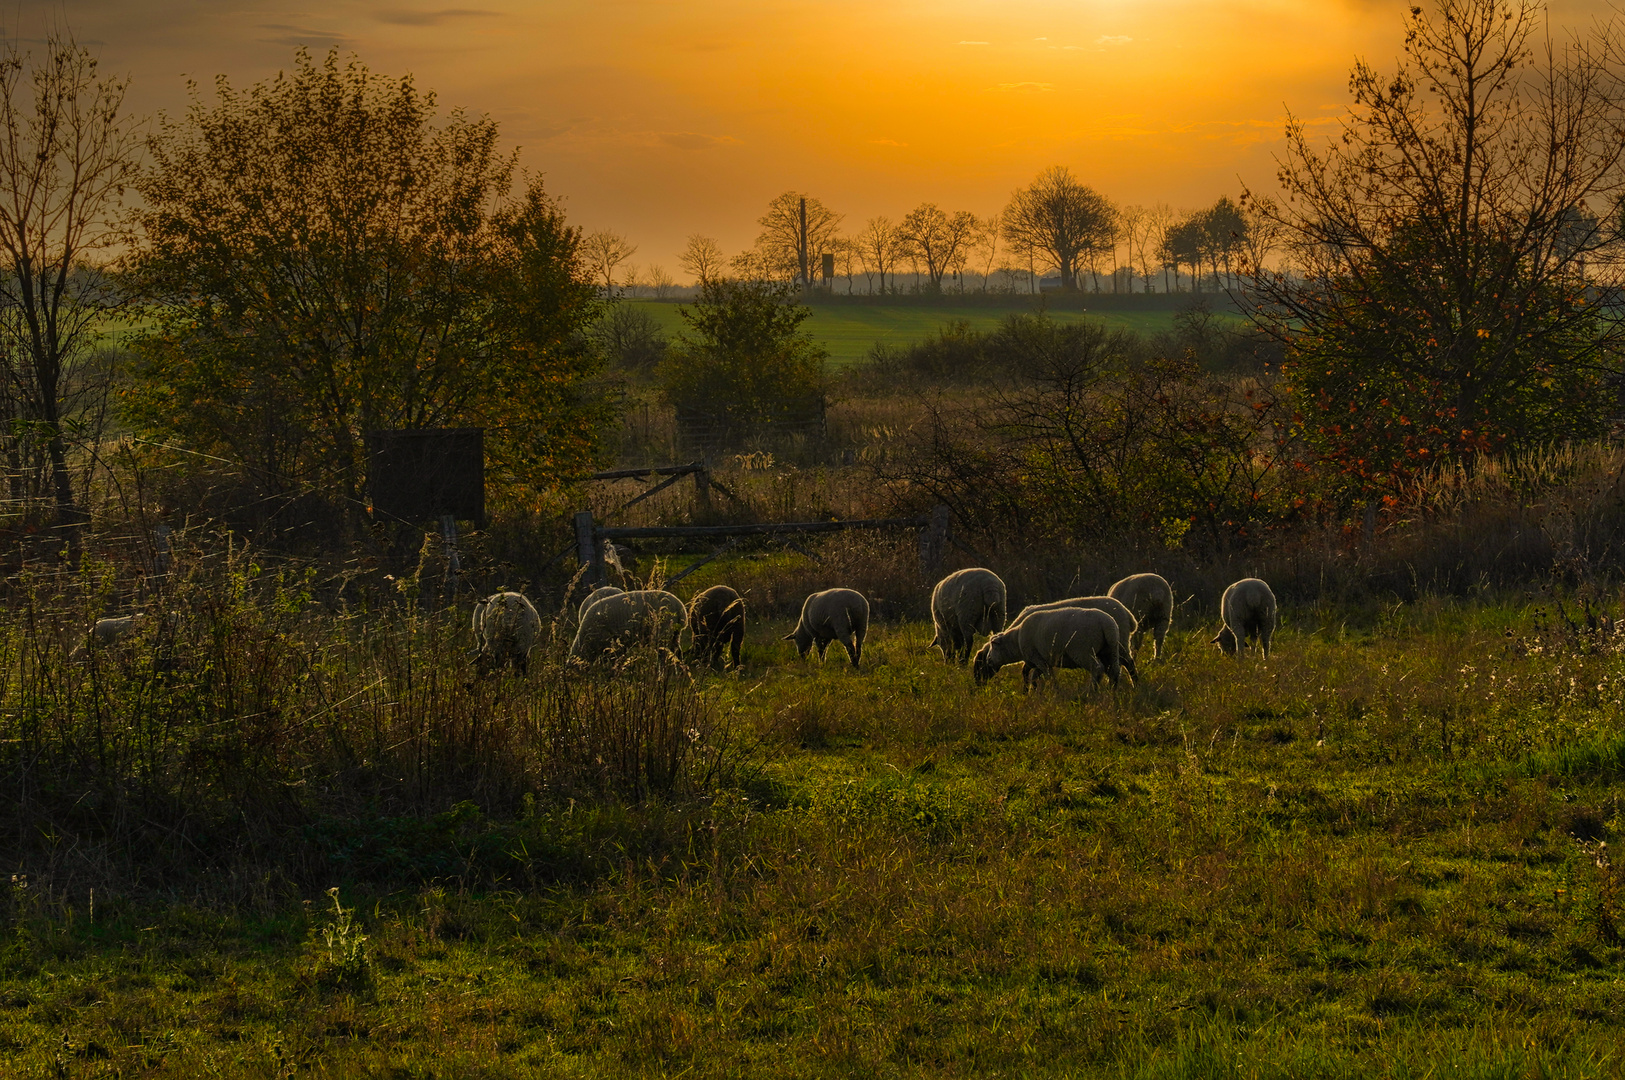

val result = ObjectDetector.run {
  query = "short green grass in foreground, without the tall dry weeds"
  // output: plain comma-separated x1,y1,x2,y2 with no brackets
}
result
0,584,1625,1080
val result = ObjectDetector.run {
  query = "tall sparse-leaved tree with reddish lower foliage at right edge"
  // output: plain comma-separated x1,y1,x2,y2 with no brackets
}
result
1250,0,1625,499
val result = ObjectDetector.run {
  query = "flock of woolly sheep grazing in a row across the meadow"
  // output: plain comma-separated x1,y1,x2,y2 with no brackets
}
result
473,567,1276,689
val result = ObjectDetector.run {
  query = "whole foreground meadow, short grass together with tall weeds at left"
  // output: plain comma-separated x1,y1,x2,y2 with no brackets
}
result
0,546,1625,1077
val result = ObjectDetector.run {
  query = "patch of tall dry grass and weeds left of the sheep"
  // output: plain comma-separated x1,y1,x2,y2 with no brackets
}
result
0,547,743,887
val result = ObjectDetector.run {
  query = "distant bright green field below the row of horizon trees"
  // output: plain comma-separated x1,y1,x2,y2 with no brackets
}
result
627,300,1209,367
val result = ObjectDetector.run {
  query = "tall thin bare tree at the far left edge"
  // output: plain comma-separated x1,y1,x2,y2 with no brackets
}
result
0,34,138,547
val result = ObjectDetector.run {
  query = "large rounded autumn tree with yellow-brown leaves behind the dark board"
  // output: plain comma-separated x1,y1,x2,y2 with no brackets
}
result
128,50,606,522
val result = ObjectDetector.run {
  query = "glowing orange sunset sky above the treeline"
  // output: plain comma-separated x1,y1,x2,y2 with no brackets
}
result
5,0,1610,274
